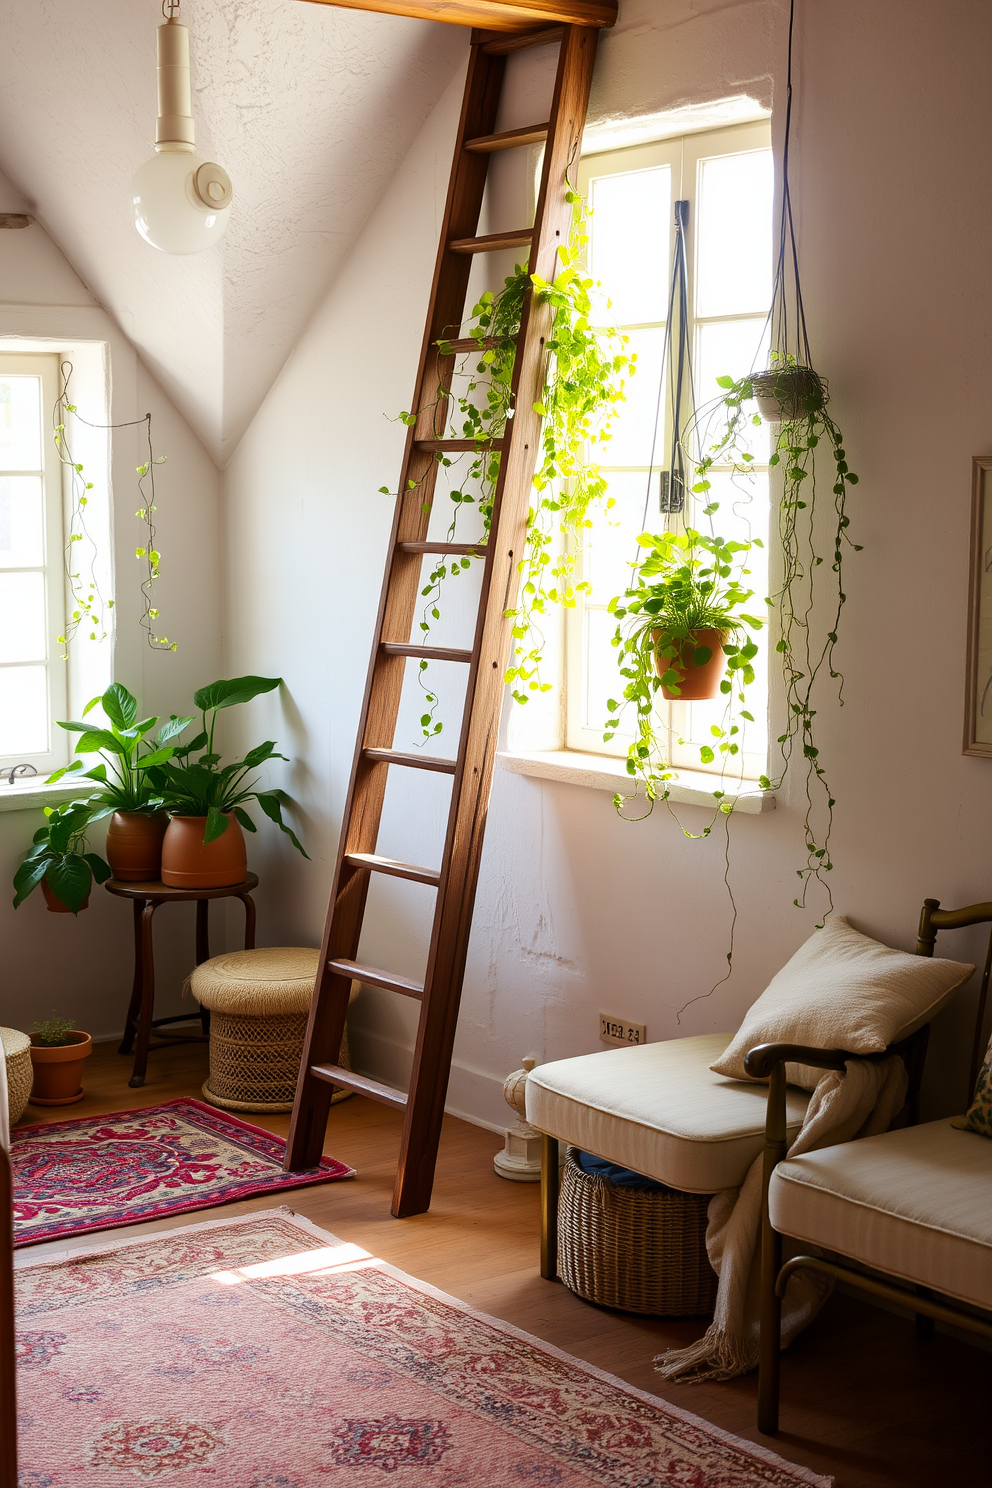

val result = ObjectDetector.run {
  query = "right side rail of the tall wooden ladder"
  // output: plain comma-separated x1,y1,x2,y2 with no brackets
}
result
393,27,596,1217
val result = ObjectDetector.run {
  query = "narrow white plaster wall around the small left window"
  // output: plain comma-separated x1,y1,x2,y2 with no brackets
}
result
0,179,225,1047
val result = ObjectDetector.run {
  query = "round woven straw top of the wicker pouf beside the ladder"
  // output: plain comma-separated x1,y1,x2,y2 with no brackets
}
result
189,945,320,1018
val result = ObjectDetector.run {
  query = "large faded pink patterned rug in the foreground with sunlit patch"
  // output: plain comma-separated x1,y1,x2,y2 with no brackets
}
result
16,1210,833,1488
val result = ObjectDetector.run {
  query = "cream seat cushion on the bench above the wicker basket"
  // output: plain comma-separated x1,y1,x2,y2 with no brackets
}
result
526,1033,809,1193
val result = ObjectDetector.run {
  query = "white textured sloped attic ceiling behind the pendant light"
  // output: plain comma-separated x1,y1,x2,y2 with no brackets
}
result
0,0,468,463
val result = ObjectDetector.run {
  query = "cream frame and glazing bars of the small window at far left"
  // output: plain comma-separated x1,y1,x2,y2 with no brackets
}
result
0,350,68,775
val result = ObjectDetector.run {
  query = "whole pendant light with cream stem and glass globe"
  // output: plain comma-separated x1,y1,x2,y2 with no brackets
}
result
131,0,233,253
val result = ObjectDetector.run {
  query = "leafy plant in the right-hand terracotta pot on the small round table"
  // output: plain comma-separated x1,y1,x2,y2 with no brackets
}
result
161,677,306,888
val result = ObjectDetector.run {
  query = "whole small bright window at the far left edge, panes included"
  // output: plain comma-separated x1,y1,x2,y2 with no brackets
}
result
0,353,67,772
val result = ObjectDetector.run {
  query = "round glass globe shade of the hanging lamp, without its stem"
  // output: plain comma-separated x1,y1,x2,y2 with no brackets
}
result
131,150,231,253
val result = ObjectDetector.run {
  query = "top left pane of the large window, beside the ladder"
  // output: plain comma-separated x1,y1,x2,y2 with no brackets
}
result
589,165,672,326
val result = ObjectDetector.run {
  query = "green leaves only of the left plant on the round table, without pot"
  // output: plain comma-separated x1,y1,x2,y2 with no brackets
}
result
49,682,193,821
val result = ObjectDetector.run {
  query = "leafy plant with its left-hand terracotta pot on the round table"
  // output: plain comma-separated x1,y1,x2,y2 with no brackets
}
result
49,682,193,882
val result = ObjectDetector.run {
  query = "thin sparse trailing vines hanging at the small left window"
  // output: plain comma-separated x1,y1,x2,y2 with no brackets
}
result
52,360,175,661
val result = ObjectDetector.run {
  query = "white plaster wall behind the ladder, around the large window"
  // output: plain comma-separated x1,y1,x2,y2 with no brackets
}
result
226,0,992,1125
